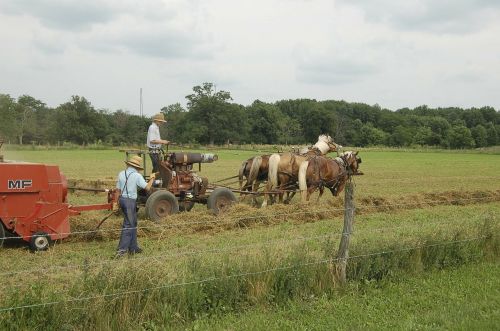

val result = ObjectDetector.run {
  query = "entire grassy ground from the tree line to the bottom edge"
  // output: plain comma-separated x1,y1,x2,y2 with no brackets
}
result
0,150,500,330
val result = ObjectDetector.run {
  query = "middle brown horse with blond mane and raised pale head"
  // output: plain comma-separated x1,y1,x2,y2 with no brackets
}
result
262,135,341,207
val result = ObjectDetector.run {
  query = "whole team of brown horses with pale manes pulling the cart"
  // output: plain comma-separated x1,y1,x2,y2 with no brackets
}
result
238,135,362,207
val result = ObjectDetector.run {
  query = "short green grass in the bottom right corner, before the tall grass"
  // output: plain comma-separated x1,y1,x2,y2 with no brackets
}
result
184,262,500,330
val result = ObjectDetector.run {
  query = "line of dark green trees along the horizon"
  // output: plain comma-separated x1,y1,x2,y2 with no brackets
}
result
0,83,500,149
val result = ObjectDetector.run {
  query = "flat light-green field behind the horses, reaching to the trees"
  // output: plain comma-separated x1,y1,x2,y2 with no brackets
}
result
4,150,500,198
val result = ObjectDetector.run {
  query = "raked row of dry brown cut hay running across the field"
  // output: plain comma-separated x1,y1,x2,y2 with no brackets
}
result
66,190,500,241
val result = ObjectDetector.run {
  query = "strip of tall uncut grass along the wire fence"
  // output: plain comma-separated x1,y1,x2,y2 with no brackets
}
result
0,220,500,330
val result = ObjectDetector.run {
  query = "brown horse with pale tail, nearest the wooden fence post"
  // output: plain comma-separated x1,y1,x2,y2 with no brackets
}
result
299,151,363,203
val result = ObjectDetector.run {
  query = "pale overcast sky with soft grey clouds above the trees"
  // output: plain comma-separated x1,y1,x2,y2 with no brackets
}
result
0,0,500,115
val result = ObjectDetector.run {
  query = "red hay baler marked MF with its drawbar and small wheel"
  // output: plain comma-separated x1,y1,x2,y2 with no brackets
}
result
0,160,116,251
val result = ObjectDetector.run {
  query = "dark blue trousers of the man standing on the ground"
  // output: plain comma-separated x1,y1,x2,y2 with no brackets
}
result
118,197,139,253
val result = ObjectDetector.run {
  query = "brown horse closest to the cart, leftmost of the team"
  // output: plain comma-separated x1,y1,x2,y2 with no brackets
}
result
238,154,270,205
